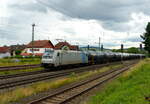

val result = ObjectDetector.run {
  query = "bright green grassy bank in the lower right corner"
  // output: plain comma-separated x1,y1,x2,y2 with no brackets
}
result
86,59,150,104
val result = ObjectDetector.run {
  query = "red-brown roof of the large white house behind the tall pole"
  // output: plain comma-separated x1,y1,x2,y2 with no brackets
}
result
27,40,54,48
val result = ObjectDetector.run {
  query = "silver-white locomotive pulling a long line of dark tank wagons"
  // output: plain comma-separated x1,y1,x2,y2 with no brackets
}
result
41,50,145,68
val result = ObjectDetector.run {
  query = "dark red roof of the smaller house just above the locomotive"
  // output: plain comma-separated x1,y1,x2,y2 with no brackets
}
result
55,42,79,50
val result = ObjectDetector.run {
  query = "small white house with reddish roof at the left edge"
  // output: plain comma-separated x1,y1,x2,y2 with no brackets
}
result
0,47,11,58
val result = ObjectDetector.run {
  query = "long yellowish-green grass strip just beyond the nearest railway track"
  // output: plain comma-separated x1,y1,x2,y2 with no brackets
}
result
0,64,123,104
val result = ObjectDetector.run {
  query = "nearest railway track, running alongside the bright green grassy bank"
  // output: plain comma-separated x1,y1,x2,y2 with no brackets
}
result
28,64,133,104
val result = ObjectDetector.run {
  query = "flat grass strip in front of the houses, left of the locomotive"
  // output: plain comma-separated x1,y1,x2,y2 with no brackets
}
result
0,58,40,66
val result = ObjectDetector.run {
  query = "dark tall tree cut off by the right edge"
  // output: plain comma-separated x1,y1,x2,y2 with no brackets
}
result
141,22,150,54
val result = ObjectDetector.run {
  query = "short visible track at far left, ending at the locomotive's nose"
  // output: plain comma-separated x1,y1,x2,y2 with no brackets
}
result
0,64,41,72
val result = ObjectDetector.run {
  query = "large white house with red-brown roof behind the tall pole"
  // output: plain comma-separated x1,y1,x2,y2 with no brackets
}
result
21,40,54,56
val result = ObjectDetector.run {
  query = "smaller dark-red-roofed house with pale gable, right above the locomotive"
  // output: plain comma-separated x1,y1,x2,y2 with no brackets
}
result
55,41,79,50
